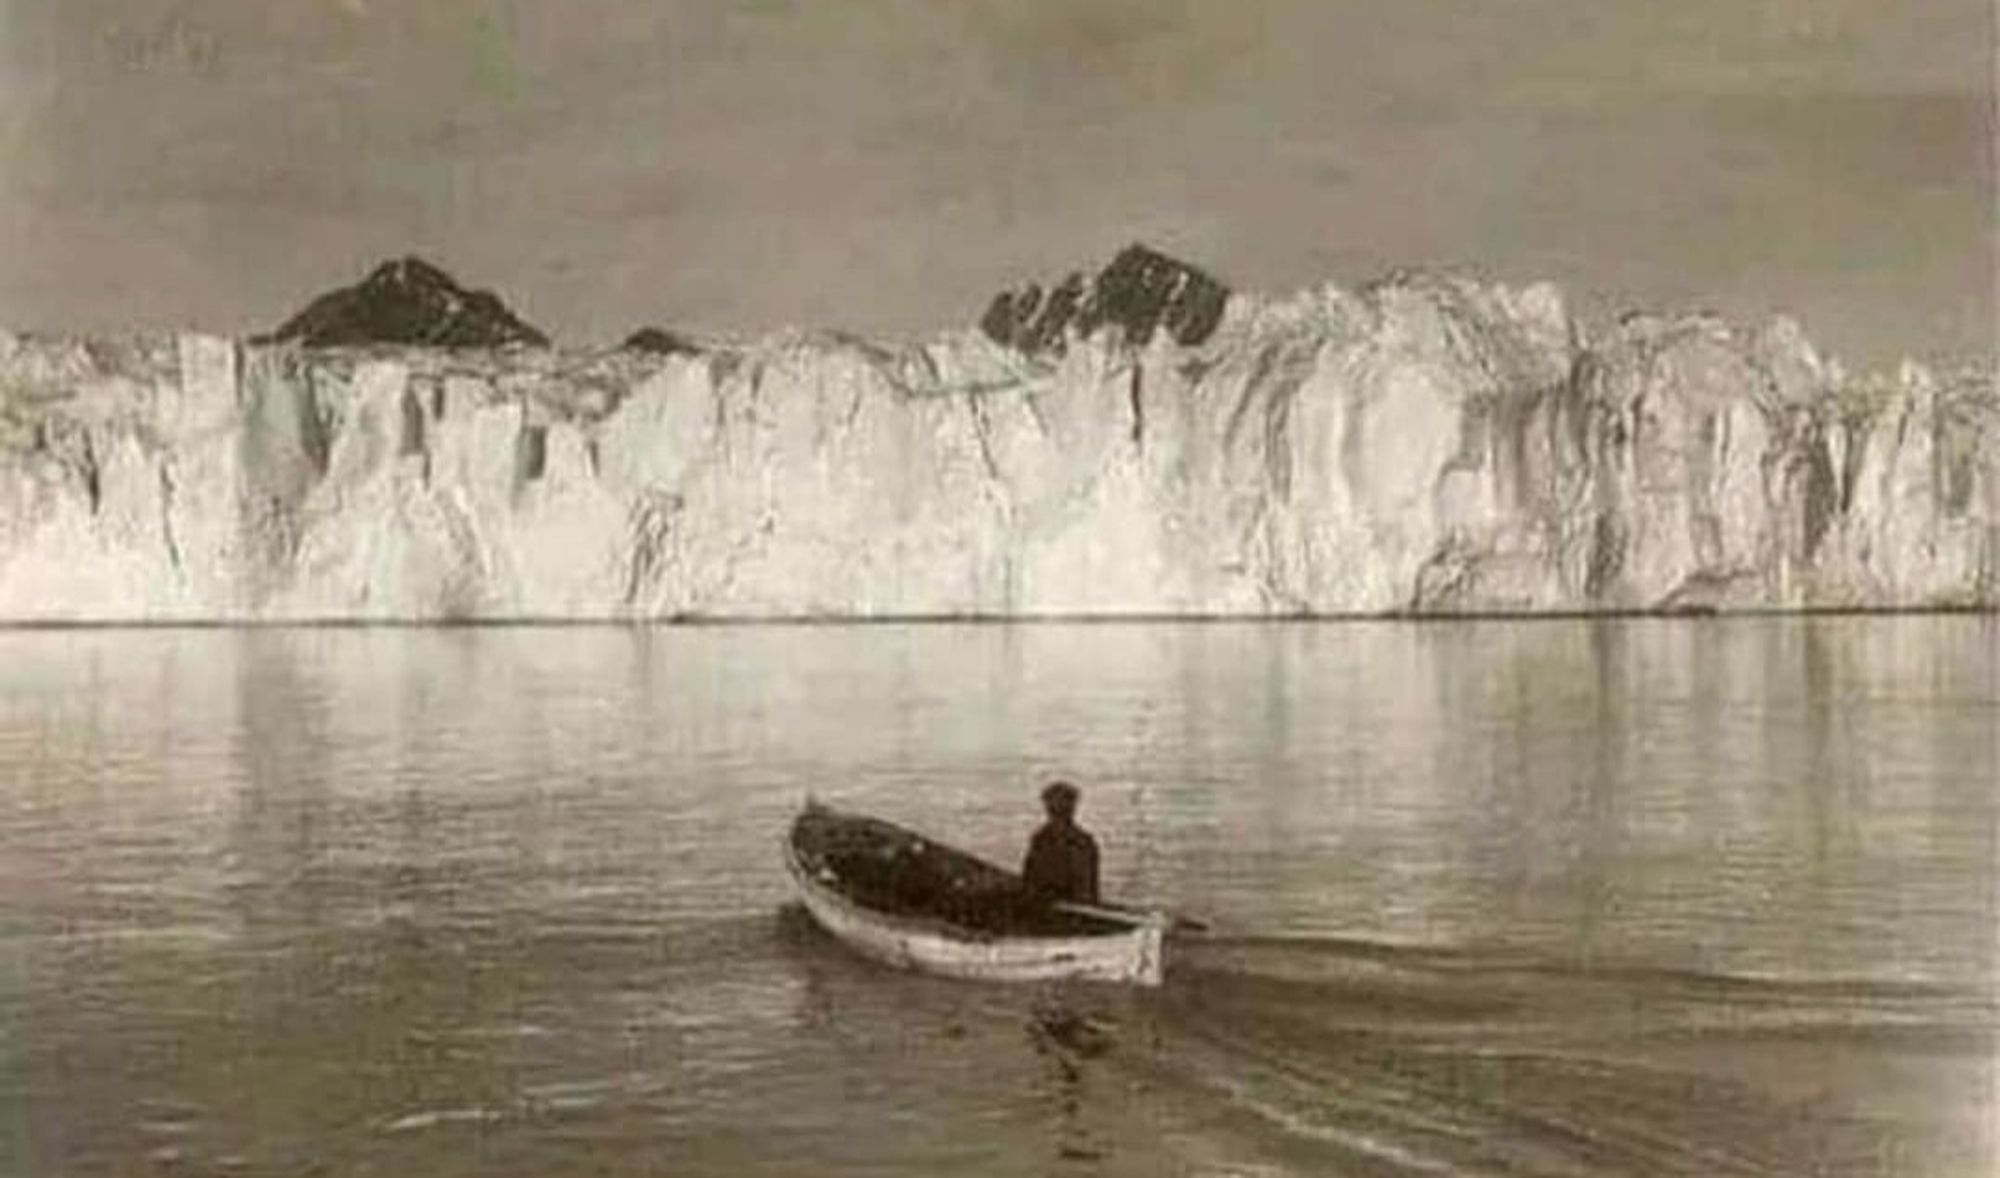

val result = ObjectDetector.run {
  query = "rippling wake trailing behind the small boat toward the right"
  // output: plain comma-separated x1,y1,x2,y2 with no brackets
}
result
1124,938,1996,1174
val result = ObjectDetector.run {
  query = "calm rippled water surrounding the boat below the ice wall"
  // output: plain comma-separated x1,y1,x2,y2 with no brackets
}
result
0,616,2000,1176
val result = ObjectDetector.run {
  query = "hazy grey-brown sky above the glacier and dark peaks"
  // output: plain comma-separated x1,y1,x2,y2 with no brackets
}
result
0,0,1996,364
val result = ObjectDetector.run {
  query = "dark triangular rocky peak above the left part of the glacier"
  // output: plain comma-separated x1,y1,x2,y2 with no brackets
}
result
254,258,548,348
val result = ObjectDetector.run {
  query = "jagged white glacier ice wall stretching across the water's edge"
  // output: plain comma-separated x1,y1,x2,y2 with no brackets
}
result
0,252,2000,620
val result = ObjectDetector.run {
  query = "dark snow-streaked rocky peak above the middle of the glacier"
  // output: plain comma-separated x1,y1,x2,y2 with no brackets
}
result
980,244,1230,356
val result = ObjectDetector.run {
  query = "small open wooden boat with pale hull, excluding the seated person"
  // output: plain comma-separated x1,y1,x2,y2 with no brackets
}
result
784,802,1168,986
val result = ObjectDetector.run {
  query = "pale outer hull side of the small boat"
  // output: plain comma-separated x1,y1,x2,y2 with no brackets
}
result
784,808,1166,986
